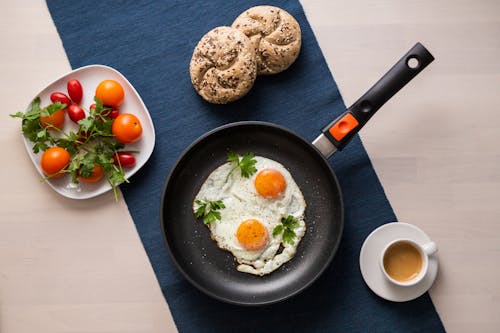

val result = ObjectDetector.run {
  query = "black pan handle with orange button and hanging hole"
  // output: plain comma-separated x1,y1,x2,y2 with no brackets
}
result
322,43,434,150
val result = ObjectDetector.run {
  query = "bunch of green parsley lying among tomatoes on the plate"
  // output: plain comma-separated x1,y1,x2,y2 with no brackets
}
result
10,97,132,200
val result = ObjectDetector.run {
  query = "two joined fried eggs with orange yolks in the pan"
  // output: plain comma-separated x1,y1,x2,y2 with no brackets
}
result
193,156,306,275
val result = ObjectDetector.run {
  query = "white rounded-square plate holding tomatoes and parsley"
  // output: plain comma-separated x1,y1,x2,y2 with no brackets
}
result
23,65,155,199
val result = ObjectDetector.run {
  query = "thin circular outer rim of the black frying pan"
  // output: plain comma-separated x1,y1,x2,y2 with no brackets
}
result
160,120,344,307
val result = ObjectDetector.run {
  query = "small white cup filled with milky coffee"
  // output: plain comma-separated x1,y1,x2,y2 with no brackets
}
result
380,238,437,287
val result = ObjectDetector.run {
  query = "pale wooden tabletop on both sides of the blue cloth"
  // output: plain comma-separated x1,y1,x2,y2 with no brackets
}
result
0,0,500,333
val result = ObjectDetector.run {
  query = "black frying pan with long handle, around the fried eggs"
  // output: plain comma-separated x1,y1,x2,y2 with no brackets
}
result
161,43,434,305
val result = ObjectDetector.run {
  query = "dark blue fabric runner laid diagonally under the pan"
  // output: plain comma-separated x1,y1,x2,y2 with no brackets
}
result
47,0,444,332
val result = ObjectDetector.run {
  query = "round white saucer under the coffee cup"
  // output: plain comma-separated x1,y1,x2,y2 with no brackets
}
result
359,222,438,302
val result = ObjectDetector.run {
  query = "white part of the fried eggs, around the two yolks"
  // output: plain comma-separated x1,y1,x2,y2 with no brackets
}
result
193,156,306,275
